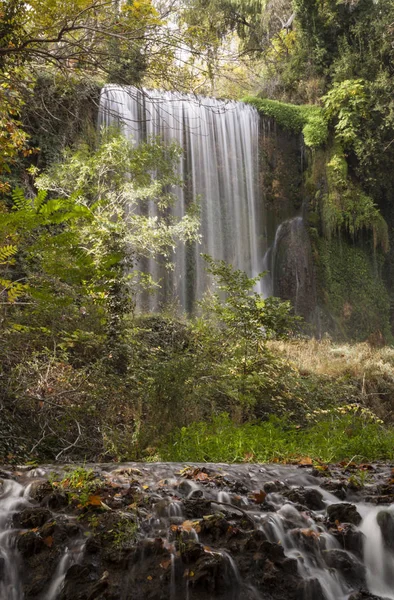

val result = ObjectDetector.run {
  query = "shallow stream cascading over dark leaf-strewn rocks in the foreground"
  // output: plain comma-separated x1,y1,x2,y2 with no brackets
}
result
0,463,394,600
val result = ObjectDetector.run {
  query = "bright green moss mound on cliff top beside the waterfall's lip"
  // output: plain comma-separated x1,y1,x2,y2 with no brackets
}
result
243,96,328,148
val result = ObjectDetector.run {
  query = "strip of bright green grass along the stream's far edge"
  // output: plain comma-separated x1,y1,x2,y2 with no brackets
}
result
160,411,394,463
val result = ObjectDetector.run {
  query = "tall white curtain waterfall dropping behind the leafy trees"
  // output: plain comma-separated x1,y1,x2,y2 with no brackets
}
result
99,85,264,311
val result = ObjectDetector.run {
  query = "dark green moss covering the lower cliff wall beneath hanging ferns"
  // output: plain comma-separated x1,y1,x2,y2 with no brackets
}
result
315,238,391,341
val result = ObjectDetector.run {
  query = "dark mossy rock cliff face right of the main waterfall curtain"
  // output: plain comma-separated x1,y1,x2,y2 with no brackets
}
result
260,116,394,344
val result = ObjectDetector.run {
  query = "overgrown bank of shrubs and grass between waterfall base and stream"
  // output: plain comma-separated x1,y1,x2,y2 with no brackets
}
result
0,328,394,463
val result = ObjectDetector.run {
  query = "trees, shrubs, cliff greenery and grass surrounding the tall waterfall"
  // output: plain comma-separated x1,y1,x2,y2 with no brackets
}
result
0,0,394,462
